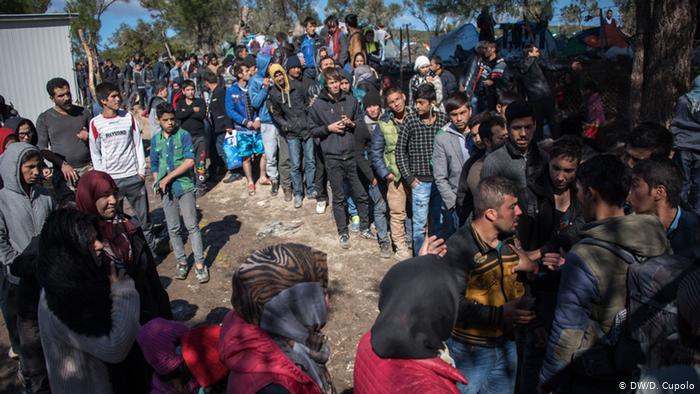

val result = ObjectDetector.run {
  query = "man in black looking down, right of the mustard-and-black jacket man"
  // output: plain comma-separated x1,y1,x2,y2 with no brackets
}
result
518,136,584,394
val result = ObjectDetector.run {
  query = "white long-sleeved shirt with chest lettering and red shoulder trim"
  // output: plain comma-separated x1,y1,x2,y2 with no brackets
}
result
89,111,146,179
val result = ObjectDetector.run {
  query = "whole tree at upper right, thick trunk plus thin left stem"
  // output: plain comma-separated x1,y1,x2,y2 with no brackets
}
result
629,0,698,126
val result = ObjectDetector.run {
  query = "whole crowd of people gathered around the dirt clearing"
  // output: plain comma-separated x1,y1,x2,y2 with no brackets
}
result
0,10,700,393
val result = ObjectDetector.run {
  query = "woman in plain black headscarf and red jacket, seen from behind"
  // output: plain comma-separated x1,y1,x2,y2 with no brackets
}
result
354,255,467,394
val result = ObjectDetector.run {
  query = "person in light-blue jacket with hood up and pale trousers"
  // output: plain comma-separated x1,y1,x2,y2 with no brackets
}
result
248,53,280,196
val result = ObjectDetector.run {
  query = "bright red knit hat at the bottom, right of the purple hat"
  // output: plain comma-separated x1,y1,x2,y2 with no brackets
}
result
182,325,228,387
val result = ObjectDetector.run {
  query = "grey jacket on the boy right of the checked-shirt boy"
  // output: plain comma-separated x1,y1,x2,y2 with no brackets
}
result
433,122,469,209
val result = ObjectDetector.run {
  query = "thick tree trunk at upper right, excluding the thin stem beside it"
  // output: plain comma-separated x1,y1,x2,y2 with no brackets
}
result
640,0,697,125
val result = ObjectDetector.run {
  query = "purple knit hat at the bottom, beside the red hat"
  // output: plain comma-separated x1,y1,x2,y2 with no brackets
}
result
136,317,188,375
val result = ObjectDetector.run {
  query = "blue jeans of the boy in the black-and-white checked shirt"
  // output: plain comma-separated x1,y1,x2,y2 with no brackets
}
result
411,182,442,256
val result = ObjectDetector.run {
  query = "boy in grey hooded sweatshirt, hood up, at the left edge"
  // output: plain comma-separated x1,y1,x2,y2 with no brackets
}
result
0,142,55,384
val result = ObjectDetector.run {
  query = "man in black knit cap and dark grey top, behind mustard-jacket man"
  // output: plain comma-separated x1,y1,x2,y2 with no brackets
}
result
481,101,548,191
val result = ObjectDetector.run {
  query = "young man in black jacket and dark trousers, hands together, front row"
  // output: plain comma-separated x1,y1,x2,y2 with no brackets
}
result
309,69,375,249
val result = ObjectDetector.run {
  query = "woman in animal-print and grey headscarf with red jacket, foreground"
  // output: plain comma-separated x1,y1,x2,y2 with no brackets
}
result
220,244,335,394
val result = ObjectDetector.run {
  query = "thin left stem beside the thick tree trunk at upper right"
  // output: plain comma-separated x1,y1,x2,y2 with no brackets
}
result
628,0,652,130
